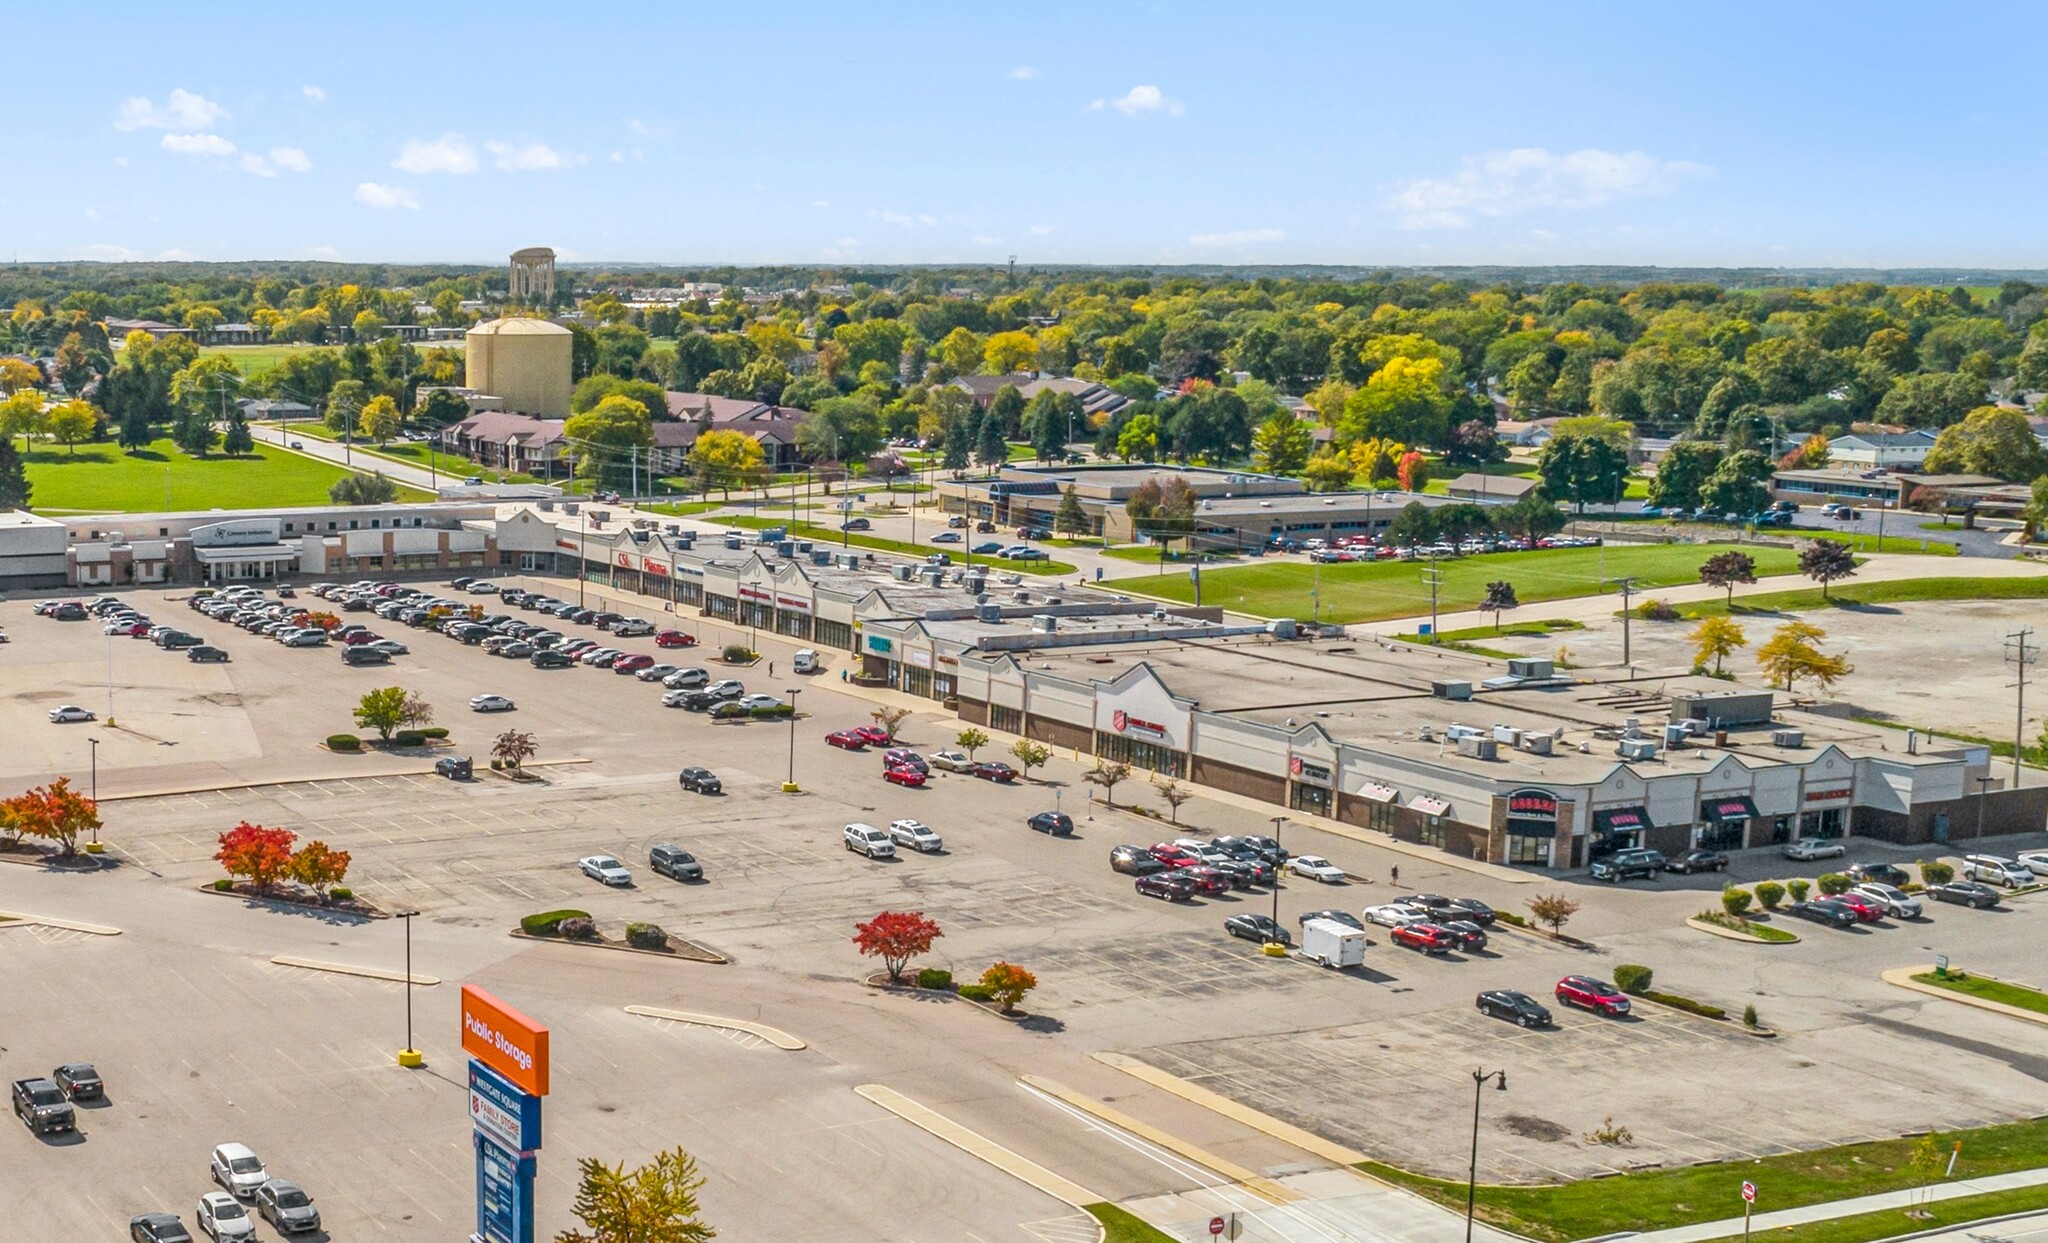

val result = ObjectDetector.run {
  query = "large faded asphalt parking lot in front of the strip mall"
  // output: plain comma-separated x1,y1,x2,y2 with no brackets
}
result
0,584,2048,1239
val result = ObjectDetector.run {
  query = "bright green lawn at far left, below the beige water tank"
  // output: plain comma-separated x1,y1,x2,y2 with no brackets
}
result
23,440,432,514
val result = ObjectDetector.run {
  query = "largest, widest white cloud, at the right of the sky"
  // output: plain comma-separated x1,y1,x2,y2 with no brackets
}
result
1389,147,1714,229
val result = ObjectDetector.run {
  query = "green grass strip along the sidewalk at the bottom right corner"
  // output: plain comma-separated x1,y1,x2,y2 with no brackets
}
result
1364,1120,2048,1243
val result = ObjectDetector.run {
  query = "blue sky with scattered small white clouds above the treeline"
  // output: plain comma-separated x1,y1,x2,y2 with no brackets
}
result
16,0,2048,268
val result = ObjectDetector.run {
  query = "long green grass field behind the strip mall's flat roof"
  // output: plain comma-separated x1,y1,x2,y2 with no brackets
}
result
1116,545,1798,623
